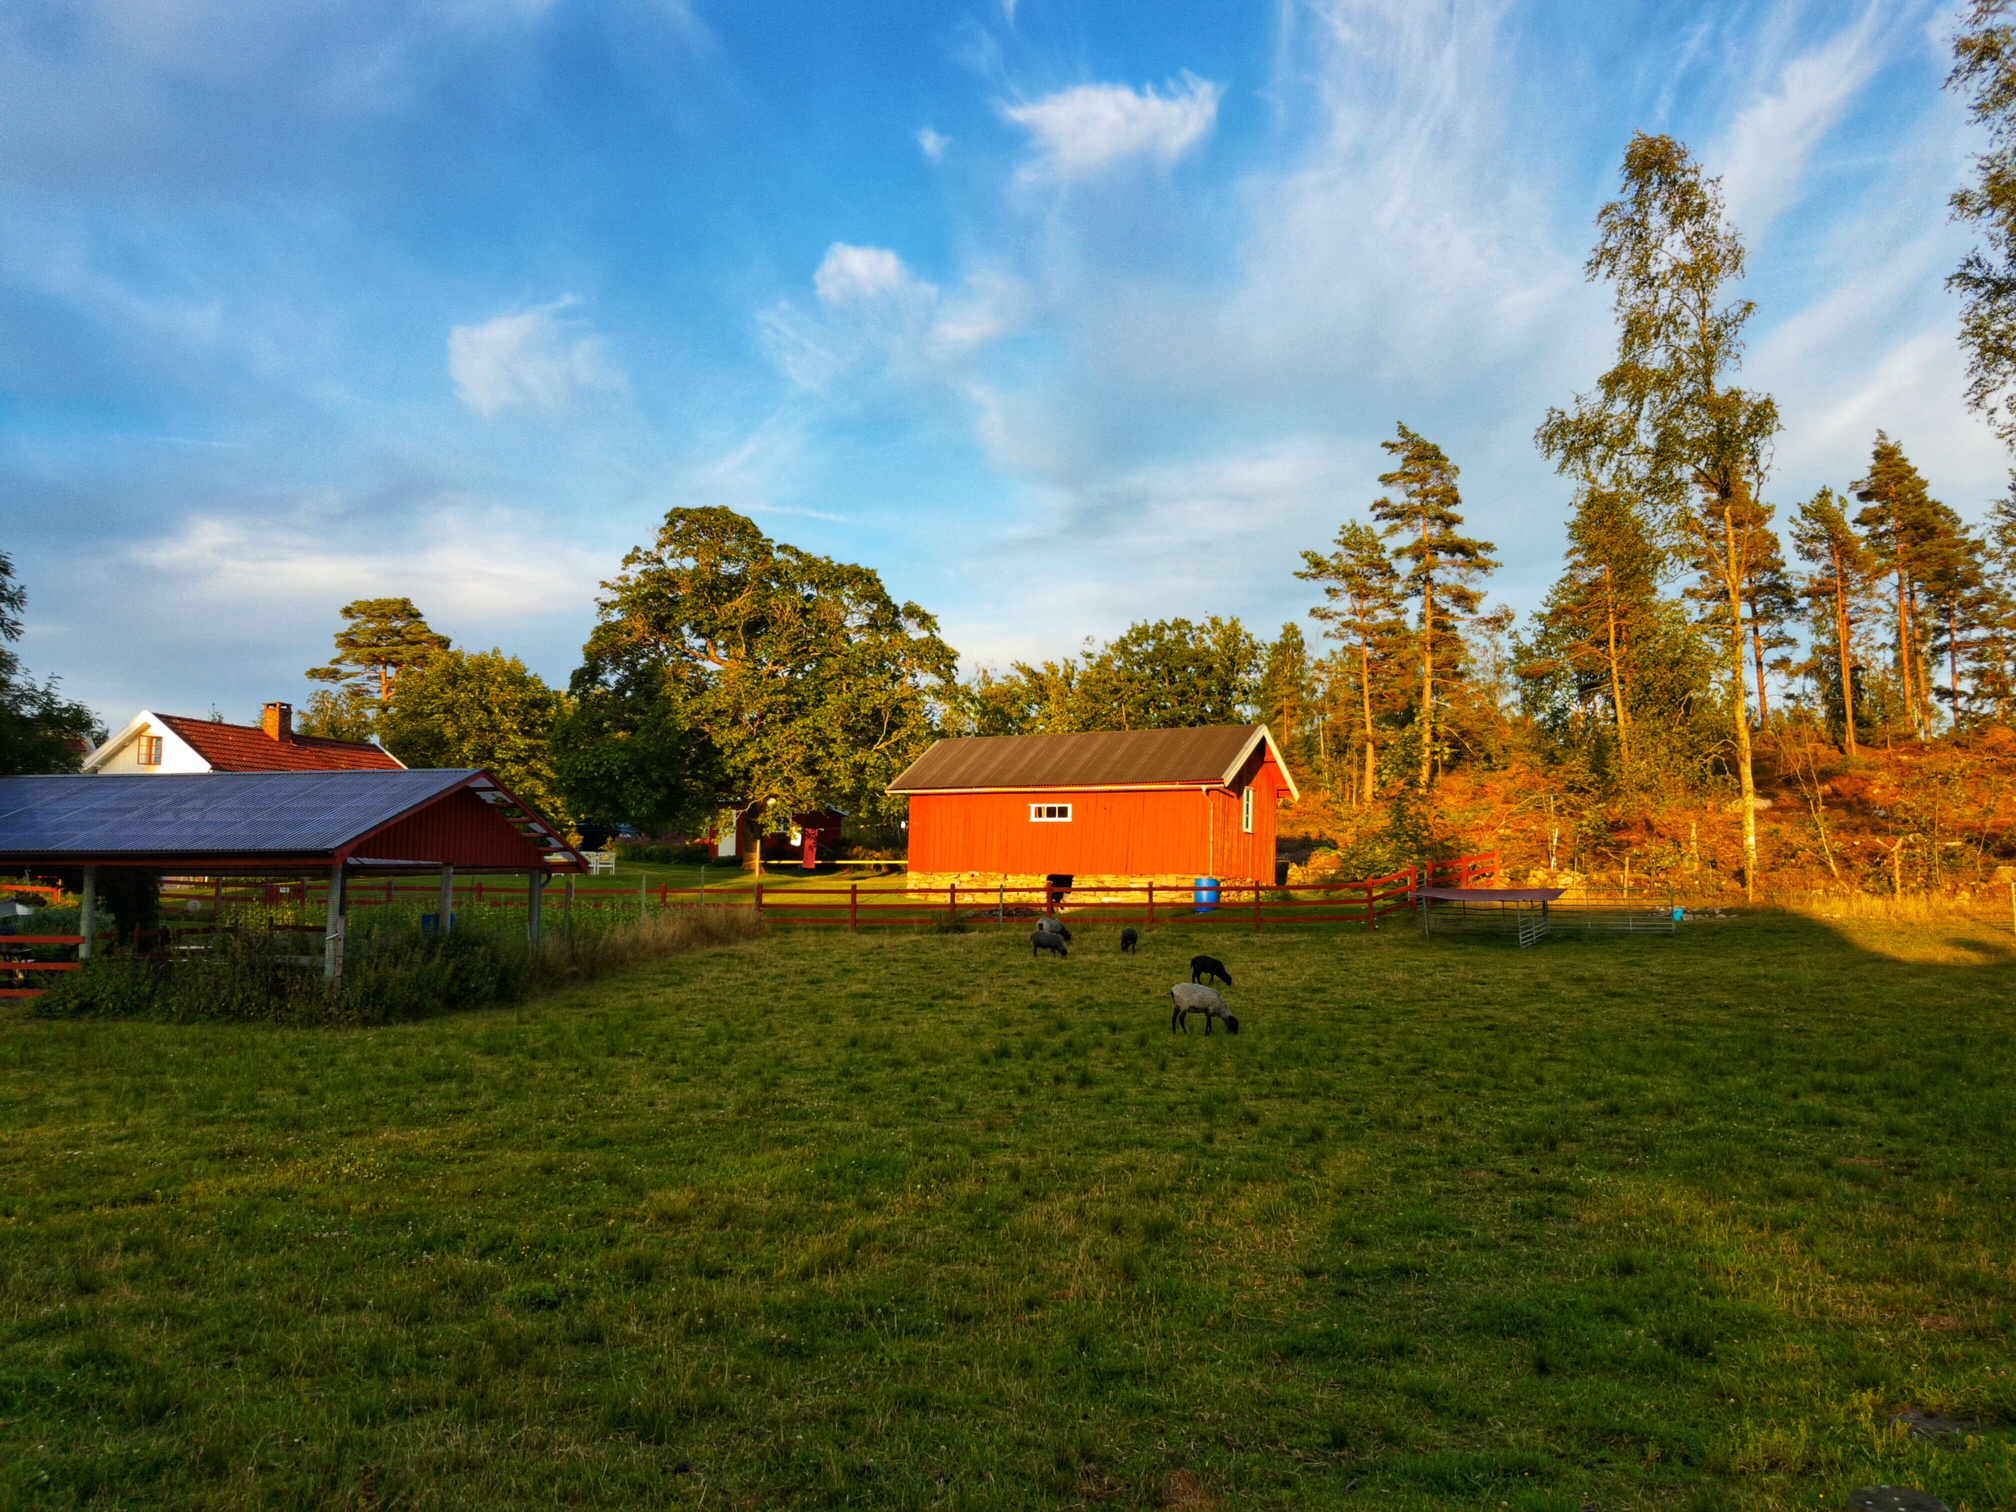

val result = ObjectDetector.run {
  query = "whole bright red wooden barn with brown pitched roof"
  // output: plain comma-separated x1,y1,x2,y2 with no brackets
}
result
889,724,1298,889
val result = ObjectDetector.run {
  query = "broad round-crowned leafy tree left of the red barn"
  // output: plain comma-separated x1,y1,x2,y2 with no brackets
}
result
566,508,958,862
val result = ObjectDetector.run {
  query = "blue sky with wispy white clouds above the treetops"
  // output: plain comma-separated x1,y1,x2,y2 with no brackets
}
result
0,0,2008,726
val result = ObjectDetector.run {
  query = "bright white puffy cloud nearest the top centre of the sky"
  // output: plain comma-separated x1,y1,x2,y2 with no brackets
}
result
1002,73,1224,179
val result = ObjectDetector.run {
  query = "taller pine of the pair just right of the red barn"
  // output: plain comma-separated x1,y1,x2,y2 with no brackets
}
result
1371,425,1498,792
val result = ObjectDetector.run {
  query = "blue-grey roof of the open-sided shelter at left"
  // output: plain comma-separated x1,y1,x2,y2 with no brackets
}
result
0,768,579,867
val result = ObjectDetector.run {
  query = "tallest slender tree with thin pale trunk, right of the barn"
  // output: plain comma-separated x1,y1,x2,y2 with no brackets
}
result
1536,135,1778,897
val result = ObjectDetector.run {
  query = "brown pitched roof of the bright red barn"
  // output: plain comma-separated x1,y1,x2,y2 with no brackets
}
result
889,724,1300,796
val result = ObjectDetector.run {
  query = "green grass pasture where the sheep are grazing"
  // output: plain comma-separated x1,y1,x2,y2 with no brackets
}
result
0,917,2016,1512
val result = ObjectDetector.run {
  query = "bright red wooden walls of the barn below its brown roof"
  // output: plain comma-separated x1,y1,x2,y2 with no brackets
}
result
909,746,1286,881
